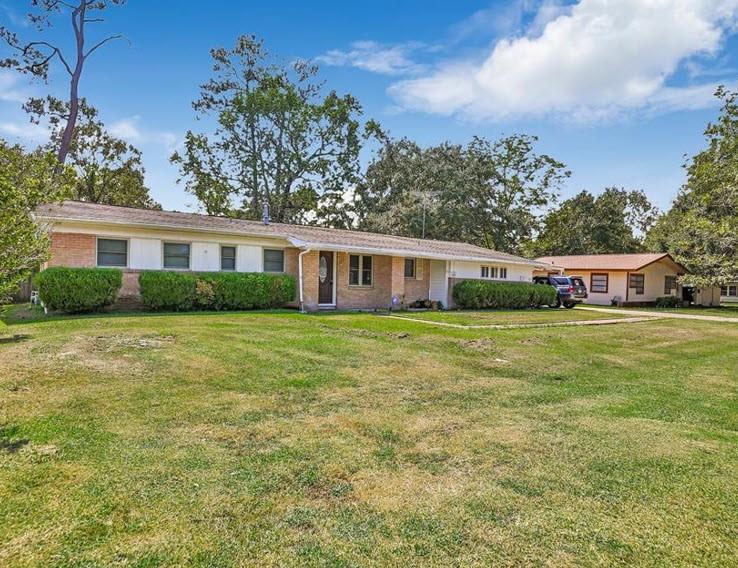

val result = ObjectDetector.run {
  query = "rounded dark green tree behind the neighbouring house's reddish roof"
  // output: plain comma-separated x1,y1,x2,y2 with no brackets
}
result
525,187,658,256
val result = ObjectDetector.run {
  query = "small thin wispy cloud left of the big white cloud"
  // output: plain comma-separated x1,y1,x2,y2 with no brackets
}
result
316,41,424,75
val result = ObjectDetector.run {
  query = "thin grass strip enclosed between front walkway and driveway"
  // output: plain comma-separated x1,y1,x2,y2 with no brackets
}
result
388,308,627,325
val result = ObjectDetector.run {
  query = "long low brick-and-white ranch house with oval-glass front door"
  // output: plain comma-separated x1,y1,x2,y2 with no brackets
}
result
36,201,546,310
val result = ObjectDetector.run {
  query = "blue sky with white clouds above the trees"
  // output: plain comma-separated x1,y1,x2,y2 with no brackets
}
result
0,0,738,210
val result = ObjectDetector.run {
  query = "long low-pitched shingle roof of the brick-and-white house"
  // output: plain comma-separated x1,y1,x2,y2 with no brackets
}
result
36,201,542,266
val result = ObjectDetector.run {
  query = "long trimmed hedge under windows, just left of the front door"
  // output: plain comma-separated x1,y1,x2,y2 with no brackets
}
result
138,271,295,311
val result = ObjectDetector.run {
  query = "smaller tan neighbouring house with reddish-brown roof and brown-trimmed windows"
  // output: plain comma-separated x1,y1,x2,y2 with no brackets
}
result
537,253,720,306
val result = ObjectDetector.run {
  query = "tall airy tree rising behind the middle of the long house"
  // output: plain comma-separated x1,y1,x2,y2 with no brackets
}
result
172,36,370,222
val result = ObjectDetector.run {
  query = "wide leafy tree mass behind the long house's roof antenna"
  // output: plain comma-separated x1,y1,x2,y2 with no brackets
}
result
355,135,569,252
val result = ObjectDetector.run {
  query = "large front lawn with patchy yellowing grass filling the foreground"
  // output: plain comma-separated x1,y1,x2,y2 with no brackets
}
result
0,304,738,567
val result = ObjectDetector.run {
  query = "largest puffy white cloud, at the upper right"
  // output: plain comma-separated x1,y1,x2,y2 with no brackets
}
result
389,0,738,121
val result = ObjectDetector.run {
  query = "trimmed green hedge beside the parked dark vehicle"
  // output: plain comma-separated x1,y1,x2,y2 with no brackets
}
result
453,280,557,309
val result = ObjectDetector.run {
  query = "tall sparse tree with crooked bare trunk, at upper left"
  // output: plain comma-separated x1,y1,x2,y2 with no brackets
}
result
0,0,126,164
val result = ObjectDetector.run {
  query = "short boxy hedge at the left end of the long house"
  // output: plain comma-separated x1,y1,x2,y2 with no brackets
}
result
35,267,123,312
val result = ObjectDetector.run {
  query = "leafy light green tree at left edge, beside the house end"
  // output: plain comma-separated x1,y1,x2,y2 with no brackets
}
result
0,140,74,299
